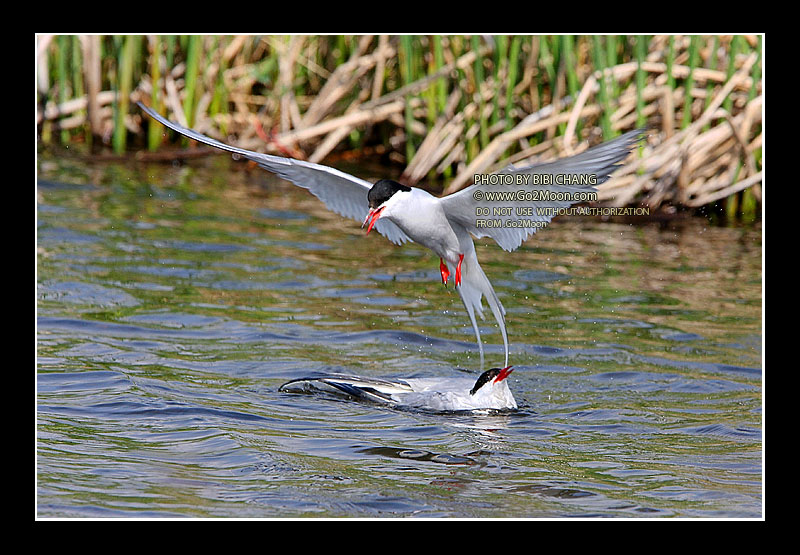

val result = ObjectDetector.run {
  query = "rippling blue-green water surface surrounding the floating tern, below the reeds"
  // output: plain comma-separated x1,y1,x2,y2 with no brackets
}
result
37,156,762,517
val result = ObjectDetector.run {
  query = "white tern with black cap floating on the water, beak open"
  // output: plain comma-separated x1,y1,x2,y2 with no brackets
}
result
278,367,517,411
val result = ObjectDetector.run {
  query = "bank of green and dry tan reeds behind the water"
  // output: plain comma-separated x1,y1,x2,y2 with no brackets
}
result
36,35,764,221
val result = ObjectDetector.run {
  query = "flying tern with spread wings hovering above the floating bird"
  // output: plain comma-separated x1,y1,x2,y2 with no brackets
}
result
139,103,643,367
